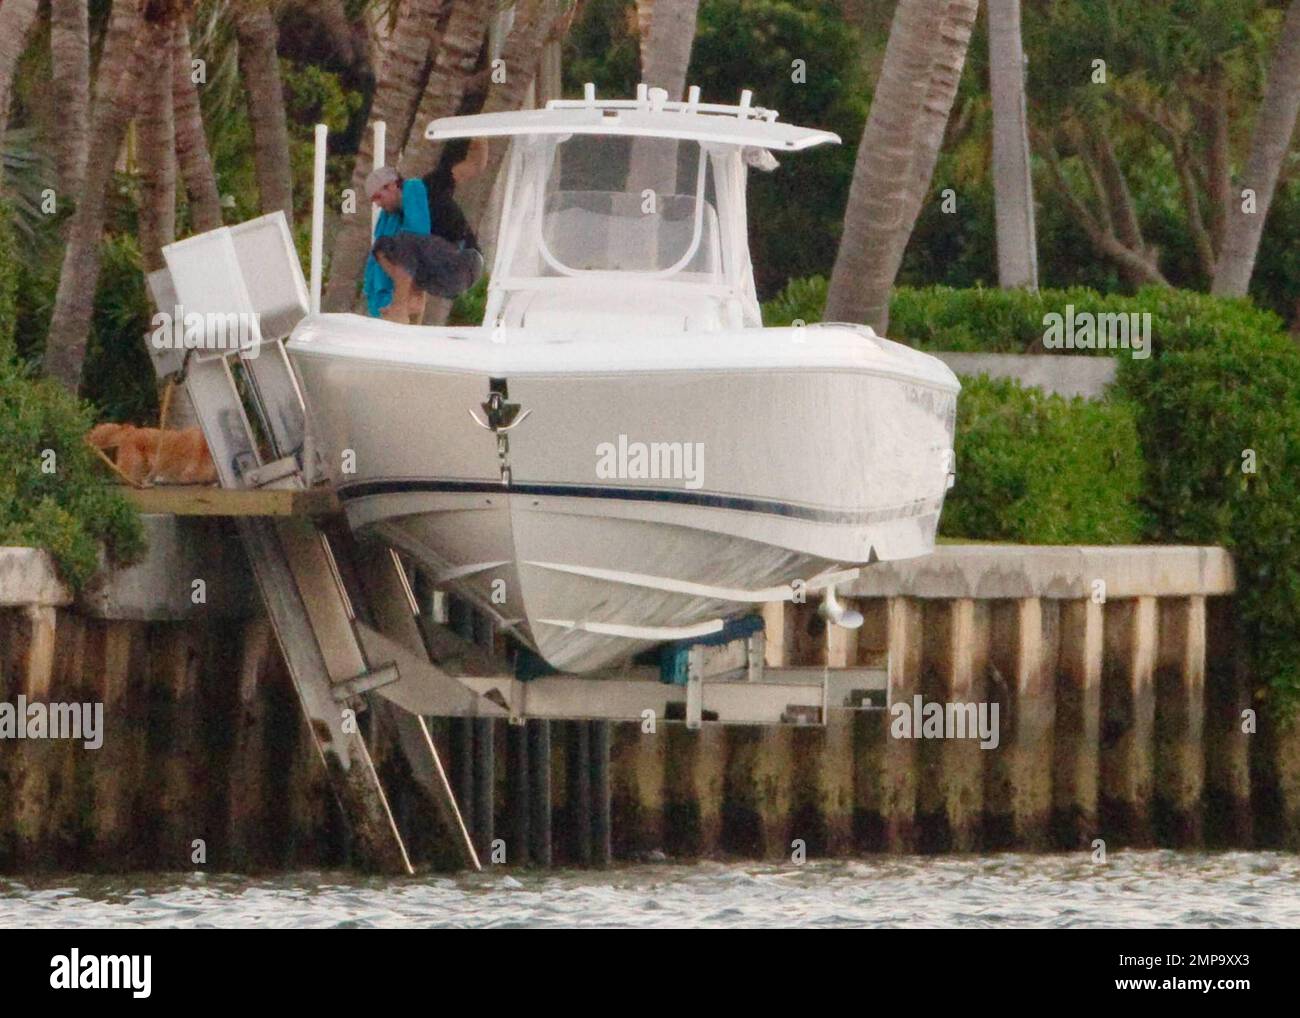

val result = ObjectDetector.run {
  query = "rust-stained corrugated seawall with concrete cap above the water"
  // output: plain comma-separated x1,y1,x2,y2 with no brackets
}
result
0,516,1300,872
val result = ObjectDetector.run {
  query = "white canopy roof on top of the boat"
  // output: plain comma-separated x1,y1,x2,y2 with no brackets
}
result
425,100,840,152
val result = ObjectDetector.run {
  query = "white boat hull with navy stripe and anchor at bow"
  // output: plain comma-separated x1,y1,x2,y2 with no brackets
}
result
289,316,957,672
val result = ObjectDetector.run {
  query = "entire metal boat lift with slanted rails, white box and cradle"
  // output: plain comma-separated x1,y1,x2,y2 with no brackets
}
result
148,115,888,874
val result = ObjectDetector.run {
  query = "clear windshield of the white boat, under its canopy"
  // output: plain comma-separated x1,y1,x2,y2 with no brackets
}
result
501,135,722,282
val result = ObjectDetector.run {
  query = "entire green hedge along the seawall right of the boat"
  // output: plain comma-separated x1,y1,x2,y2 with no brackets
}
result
763,280,1300,707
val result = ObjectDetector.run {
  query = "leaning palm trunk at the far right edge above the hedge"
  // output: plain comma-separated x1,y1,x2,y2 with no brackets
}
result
1210,0,1300,296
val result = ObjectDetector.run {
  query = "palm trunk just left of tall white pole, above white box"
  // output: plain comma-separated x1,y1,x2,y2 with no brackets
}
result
235,0,294,222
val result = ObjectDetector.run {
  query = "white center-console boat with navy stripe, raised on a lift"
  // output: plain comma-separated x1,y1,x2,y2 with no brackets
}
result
287,86,959,672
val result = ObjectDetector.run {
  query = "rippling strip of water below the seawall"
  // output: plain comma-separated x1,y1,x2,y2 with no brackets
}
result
0,850,1300,928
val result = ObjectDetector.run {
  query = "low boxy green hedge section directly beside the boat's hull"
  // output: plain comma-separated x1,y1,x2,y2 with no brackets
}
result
940,377,1144,545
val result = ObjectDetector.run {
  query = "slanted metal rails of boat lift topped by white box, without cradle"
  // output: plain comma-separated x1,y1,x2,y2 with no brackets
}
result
150,212,493,874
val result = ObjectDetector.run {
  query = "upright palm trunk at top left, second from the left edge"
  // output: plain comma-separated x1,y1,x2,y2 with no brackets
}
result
49,0,90,195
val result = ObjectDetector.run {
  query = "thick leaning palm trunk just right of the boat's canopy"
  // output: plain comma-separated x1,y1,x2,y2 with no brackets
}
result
826,0,979,333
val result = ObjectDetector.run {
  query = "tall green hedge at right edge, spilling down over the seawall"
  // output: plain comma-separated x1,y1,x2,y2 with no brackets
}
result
1119,329,1300,707
